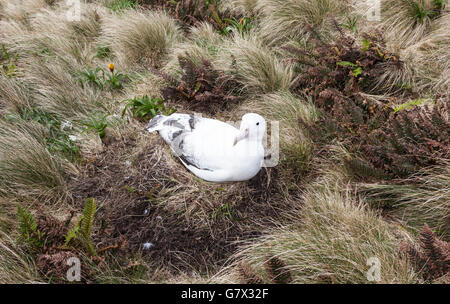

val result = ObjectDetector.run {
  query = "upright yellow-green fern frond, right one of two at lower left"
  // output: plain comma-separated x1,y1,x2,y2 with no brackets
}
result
64,198,97,256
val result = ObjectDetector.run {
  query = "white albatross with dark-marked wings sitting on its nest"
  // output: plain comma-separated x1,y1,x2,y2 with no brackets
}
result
145,113,266,182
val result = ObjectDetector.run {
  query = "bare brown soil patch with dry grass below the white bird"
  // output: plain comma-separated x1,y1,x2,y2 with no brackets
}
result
75,136,286,272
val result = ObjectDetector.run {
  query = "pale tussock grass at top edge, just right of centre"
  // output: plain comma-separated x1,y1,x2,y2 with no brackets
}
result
256,0,348,43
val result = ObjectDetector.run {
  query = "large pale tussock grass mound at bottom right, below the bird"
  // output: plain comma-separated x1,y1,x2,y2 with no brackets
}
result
221,181,419,284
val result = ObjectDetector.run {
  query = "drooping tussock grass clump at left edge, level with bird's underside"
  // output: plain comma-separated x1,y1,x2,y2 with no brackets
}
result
0,122,77,201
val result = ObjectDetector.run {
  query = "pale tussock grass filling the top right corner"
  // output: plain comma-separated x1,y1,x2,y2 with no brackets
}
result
352,0,450,94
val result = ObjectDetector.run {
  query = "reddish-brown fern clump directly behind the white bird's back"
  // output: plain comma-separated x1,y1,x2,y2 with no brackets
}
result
162,53,240,114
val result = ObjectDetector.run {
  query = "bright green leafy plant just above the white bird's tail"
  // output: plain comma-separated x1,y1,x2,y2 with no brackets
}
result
122,95,175,119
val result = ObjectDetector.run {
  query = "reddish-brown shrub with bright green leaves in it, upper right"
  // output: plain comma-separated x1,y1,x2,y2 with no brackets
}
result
285,28,403,100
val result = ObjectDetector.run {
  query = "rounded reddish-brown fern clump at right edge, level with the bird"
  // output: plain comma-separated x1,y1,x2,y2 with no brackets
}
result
361,102,450,177
